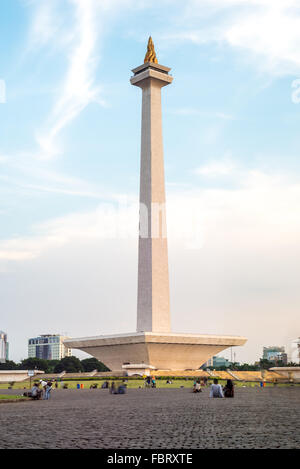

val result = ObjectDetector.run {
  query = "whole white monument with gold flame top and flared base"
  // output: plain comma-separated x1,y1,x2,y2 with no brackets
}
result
64,37,246,374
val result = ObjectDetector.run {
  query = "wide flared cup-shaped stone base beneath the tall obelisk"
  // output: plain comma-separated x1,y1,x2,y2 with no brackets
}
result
64,332,247,371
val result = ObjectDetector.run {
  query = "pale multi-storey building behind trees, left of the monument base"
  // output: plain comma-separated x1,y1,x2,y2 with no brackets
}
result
28,334,72,360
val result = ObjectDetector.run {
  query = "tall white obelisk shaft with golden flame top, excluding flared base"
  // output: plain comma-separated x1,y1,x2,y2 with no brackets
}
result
130,37,173,332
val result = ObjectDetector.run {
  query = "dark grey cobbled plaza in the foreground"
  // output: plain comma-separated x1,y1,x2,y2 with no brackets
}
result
0,384,300,449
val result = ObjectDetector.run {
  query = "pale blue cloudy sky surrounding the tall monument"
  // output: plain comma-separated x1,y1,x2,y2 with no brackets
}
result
0,0,300,362
